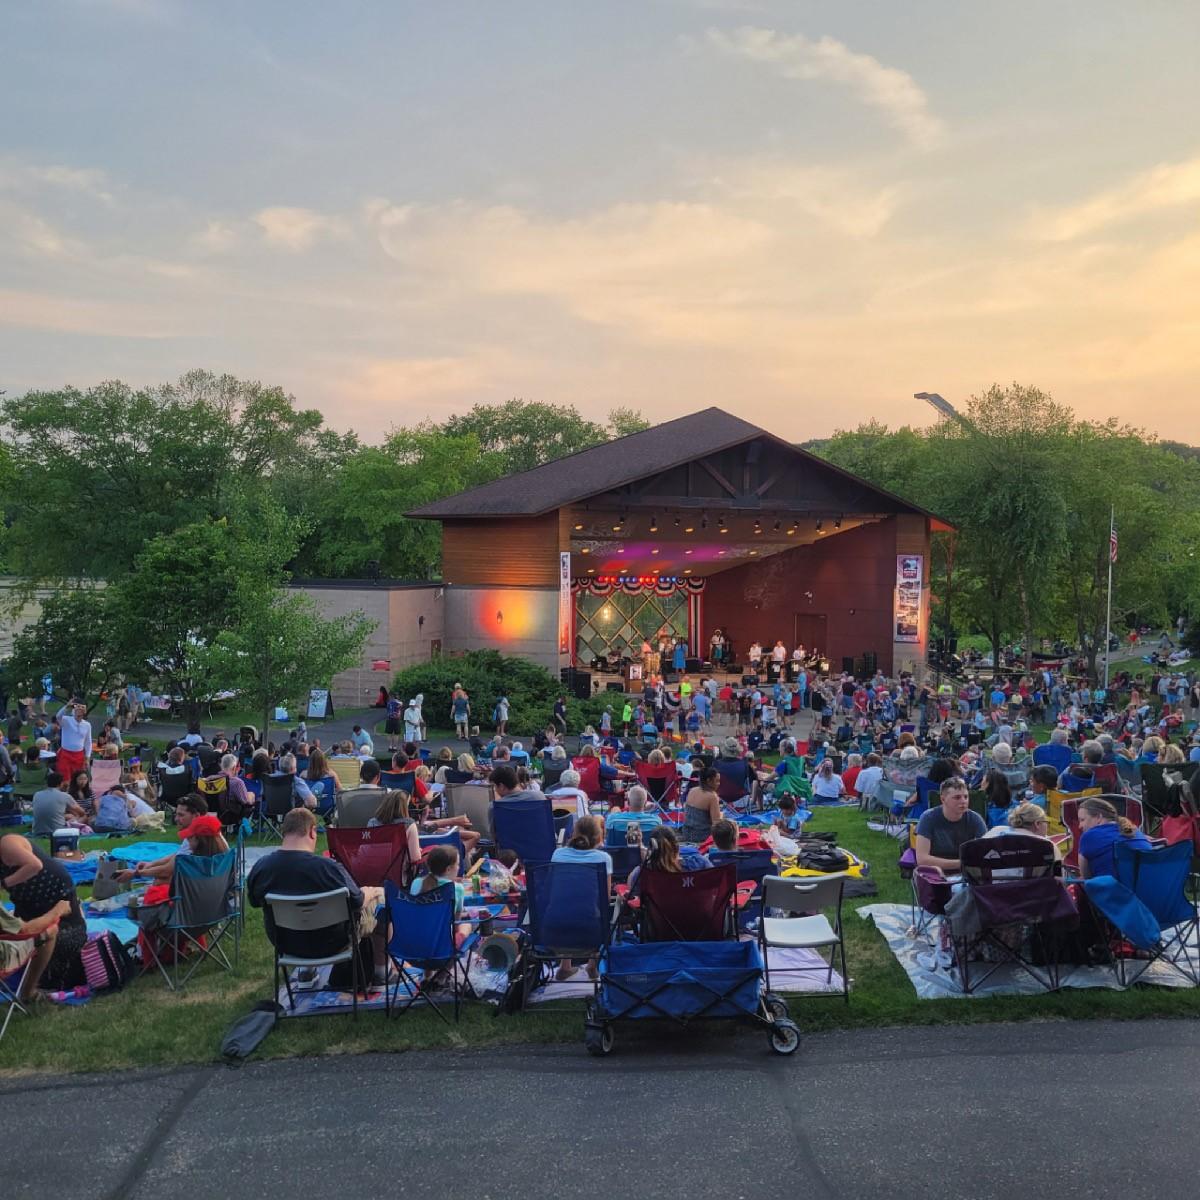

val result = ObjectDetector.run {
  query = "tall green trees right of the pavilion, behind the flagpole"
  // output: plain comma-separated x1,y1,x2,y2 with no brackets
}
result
809,384,1200,677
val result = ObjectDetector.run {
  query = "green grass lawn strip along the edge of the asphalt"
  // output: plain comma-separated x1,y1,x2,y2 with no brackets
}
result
7,809,1200,1074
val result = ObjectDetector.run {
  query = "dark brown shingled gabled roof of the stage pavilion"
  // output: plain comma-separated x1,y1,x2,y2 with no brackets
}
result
407,408,934,520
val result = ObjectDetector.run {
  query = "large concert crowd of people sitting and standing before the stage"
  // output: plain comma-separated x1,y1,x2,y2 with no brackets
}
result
0,652,1200,1012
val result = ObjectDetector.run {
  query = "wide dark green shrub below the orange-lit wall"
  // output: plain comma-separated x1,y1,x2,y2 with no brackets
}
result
392,650,638,737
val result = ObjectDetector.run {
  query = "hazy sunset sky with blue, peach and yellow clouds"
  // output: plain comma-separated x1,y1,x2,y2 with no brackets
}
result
0,0,1200,443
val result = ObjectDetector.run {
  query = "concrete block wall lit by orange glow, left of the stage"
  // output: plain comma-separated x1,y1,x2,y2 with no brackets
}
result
442,586,559,674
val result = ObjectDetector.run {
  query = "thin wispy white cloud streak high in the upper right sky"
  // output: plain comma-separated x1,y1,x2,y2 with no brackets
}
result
707,25,943,149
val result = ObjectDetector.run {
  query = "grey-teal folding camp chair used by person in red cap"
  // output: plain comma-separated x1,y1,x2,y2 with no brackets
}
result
138,850,241,991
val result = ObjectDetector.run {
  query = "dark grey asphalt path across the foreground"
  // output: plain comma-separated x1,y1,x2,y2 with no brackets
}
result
9,1021,1200,1200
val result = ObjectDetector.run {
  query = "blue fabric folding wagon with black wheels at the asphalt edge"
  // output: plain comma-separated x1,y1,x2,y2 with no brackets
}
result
583,942,800,1055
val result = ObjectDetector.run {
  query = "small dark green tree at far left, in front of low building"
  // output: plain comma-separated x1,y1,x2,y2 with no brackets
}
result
8,587,125,698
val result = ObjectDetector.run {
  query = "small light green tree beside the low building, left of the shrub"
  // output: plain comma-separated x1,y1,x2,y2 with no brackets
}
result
210,584,374,736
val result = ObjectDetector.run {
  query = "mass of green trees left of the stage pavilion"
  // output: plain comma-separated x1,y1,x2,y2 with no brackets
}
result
0,371,647,726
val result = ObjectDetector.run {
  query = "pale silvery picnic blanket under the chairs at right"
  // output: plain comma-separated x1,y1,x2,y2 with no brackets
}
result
857,904,1198,1000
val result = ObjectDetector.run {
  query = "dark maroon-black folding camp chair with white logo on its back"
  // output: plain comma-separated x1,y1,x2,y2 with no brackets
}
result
946,834,1079,996
